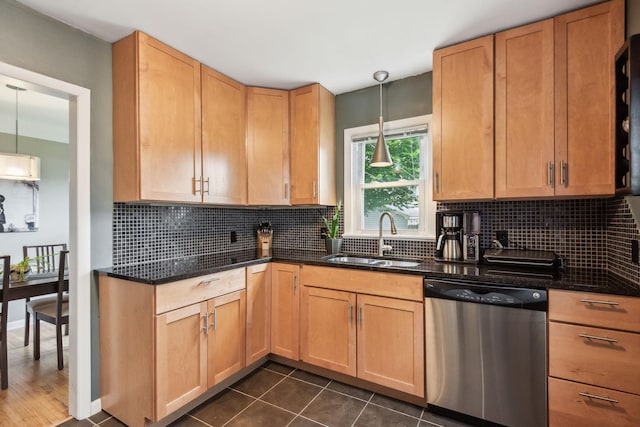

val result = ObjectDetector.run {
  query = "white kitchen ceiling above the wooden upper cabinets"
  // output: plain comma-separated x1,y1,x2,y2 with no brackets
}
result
18,0,598,94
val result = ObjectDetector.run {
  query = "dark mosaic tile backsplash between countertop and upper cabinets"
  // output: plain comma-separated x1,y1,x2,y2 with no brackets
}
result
113,197,640,283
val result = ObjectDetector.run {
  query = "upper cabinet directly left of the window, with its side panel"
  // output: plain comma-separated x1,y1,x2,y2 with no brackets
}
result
289,83,336,205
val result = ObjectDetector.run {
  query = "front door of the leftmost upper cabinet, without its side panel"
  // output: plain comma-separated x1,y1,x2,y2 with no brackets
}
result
138,33,202,202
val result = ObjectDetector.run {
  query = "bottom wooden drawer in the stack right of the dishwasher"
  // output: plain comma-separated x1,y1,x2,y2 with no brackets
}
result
549,378,640,427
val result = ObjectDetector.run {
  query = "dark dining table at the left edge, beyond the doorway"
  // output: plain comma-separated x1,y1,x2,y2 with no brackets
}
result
0,271,69,390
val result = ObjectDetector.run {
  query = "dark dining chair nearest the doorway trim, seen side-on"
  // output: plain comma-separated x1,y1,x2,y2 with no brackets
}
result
27,251,69,370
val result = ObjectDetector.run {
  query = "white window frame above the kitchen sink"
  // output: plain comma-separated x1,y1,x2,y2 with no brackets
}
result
343,114,436,240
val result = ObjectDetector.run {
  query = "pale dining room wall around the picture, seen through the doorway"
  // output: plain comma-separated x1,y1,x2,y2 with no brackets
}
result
0,133,69,322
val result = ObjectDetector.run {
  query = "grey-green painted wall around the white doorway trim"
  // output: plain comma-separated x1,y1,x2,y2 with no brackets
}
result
0,0,113,399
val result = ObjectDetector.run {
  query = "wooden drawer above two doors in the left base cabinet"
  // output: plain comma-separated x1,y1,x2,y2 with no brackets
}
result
156,268,246,314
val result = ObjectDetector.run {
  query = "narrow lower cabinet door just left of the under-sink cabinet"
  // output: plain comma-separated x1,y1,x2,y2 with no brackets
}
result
271,263,300,360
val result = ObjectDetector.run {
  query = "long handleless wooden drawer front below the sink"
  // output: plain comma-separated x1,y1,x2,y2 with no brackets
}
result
302,265,424,302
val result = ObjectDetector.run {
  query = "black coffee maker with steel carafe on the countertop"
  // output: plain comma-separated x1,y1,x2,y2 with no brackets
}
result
435,211,480,263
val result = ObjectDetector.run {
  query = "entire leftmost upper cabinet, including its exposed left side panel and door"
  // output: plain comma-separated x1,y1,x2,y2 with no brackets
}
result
112,31,201,202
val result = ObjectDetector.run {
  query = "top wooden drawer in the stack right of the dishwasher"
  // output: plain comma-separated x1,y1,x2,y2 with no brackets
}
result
549,289,640,332
